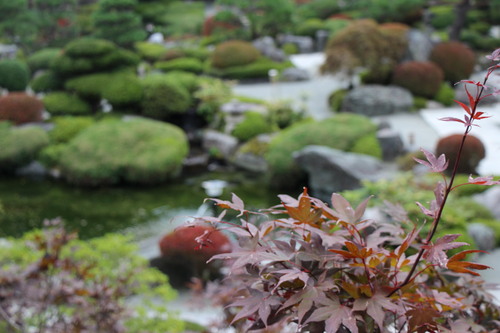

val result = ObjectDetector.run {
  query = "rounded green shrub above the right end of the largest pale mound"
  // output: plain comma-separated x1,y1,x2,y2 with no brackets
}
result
141,75,192,120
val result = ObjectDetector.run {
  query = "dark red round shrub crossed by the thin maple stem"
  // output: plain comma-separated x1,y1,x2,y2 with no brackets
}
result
436,134,486,174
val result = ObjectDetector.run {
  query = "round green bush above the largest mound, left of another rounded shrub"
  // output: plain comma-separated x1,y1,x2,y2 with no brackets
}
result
101,74,144,111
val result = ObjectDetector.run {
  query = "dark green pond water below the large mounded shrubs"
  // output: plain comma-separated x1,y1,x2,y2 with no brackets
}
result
0,173,279,239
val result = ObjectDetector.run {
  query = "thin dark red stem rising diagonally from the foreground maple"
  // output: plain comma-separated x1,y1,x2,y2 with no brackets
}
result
387,73,491,297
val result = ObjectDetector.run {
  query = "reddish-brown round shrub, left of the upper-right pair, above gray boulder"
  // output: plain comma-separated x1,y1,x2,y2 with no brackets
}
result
392,61,444,98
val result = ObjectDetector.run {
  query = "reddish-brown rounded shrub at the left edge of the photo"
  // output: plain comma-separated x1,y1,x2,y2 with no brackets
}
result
0,92,43,125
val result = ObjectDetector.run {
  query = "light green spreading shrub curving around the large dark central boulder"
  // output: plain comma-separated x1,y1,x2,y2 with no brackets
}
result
266,113,376,187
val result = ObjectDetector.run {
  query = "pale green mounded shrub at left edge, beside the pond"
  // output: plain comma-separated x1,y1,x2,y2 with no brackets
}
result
0,122,49,173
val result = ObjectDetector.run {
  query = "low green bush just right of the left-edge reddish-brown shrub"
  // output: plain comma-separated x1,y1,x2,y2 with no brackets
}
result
43,92,92,115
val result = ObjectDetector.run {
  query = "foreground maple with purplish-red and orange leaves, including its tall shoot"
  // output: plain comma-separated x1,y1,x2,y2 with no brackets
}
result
189,49,500,333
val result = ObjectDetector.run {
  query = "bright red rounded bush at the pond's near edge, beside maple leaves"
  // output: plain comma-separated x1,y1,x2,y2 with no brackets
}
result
159,226,231,262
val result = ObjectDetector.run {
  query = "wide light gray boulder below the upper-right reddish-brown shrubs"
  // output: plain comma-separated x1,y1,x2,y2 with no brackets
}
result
341,84,413,117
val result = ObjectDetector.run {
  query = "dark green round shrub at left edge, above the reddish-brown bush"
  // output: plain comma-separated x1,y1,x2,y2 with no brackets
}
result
0,59,30,91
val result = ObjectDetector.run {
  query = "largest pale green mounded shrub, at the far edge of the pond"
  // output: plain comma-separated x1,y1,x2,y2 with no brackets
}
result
58,118,188,186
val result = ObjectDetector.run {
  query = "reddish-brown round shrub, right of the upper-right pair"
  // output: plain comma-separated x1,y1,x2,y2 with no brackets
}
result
430,42,476,84
